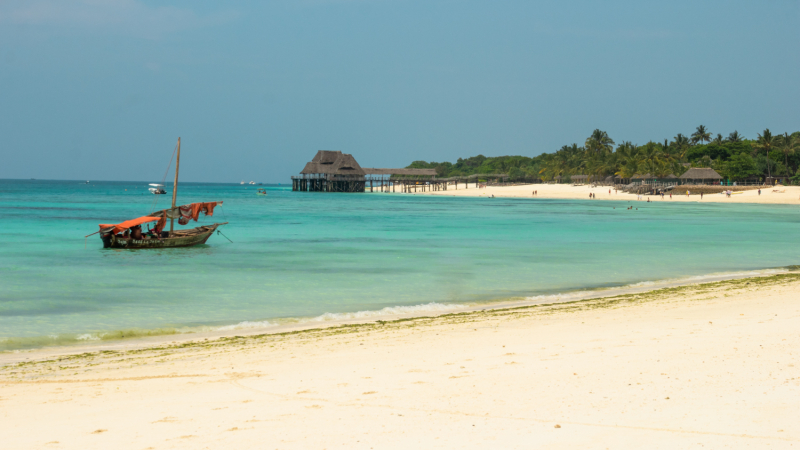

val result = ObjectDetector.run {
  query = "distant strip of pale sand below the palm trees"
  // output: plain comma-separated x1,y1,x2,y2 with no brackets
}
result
394,184,800,205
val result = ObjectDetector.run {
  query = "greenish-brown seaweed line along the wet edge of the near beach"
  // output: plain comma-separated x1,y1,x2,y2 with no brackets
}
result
0,272,800,383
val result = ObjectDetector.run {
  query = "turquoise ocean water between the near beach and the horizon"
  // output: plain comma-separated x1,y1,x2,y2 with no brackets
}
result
0,180,800,350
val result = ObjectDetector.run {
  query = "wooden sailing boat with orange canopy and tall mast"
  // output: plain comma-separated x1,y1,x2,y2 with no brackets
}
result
91,138,228,249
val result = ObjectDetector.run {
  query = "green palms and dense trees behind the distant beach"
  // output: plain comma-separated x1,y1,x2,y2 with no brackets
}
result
408,125,800,183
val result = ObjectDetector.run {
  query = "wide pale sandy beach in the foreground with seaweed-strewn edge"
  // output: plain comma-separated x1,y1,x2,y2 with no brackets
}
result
0,272,800,449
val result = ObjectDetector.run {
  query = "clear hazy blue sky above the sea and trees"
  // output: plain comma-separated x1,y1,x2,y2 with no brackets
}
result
0,0,800,183
